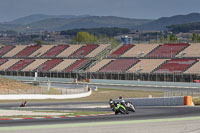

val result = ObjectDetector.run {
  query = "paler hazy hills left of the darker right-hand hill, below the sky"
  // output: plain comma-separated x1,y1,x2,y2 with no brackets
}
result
0,15,153,31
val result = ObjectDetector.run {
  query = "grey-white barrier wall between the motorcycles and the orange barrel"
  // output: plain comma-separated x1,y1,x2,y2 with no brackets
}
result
115,97,184,106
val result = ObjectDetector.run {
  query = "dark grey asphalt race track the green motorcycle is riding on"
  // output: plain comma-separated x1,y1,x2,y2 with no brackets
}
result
0,102,200,127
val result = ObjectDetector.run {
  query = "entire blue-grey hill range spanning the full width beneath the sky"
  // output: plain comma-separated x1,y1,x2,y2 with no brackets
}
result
0,13,200,32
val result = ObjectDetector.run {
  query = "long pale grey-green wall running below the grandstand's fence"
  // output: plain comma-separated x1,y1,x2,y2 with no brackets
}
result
3,76,200,88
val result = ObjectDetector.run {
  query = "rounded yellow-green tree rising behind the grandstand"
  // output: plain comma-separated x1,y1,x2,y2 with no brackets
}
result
72,32,97,43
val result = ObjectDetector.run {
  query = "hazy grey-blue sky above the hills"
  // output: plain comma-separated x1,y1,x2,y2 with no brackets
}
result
0,0,200,22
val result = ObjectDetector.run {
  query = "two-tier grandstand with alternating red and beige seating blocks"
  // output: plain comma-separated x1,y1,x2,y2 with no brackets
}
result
0,43,200,81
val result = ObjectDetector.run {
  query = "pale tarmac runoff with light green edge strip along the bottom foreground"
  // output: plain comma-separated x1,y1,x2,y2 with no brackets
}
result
0,117,200,133
